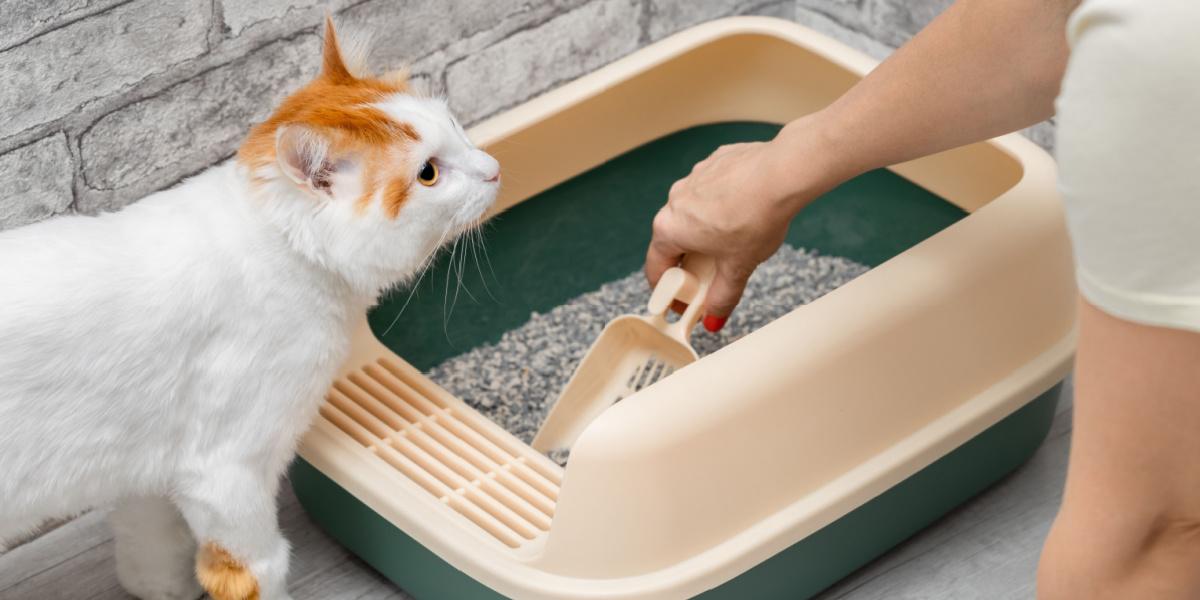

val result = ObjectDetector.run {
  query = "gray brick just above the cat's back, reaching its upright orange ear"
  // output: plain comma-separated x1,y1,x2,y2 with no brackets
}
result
78,34,320,212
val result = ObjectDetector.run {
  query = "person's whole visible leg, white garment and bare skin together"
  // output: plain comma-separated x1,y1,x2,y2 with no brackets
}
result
1038,0,1200,600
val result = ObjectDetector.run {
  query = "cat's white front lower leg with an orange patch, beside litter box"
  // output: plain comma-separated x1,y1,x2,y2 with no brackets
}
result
176,466,289,600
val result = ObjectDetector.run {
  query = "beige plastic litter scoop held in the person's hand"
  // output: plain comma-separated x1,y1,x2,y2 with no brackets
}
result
533,254,716,452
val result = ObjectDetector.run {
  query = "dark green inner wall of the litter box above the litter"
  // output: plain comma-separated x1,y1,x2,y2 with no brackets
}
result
368,121,967,369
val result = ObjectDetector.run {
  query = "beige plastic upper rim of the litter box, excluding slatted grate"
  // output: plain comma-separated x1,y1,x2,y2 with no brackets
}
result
292,17,1075,599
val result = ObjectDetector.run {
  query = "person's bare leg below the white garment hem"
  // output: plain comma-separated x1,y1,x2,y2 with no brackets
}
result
1038,302,1200,600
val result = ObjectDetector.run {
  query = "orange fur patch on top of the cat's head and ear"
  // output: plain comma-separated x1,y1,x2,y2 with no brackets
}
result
238,19,421,218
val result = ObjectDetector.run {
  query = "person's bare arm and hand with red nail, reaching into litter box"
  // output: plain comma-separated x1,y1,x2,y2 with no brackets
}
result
646,0,1076,329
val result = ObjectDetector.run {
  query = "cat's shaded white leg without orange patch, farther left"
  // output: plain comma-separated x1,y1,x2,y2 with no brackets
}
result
108,497,204,600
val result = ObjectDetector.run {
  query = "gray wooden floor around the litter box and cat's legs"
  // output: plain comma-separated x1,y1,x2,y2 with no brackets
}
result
0,385,1073,600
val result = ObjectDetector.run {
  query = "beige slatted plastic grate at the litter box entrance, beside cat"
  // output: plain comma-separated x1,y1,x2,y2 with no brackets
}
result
320,358,562,548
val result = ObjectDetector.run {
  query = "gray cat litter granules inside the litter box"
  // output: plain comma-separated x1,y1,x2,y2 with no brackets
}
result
428,245,868,463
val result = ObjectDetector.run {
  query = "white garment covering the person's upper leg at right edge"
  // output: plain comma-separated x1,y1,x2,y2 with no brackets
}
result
1056,0,1200,331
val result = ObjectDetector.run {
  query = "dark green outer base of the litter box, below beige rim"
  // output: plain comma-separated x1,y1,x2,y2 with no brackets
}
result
289,384,1062,600
